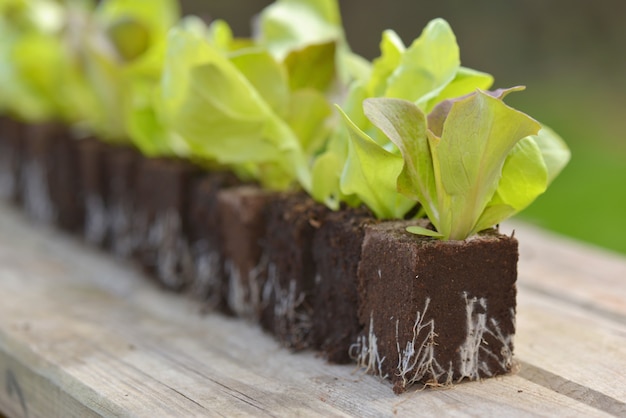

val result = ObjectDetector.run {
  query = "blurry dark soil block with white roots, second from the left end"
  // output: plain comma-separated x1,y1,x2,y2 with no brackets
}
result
21,123,84,232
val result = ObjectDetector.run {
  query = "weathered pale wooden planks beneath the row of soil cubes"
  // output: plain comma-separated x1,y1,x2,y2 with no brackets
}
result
0,205,626,417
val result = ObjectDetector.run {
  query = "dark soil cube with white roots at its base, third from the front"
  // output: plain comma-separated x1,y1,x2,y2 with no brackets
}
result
261,193,328,350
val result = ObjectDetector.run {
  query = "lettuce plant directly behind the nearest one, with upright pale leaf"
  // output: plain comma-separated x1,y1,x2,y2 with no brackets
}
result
313,19,493,211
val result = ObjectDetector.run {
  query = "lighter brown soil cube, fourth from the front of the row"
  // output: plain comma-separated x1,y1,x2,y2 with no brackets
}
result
218,185,276,321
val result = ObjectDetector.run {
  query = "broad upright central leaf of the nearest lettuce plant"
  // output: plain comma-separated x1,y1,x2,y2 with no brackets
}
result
429,91,541,239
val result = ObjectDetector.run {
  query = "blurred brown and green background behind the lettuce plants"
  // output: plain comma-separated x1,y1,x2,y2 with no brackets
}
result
182,0,626,253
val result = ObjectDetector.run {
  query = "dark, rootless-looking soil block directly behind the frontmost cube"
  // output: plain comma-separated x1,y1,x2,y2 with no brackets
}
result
312,209,376,363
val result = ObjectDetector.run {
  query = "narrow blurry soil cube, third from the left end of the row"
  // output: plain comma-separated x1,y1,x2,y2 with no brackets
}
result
77,137,109,246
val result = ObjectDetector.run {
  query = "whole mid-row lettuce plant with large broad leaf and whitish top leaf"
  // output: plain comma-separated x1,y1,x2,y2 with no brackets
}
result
161,0,354,191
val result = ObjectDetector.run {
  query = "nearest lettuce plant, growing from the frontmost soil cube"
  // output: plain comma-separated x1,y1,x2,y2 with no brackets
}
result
342,87,570,240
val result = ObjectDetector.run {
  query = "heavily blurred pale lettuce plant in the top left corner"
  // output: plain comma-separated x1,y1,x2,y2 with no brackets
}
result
0,0,93,124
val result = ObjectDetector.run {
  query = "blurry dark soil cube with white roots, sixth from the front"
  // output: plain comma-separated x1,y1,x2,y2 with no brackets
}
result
134,158,198,291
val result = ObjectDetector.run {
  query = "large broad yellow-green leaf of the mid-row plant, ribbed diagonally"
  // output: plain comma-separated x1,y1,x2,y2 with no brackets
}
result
161,22,310,190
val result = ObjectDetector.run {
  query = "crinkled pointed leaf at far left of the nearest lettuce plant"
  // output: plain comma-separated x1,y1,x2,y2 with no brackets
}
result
340,105,415,219
